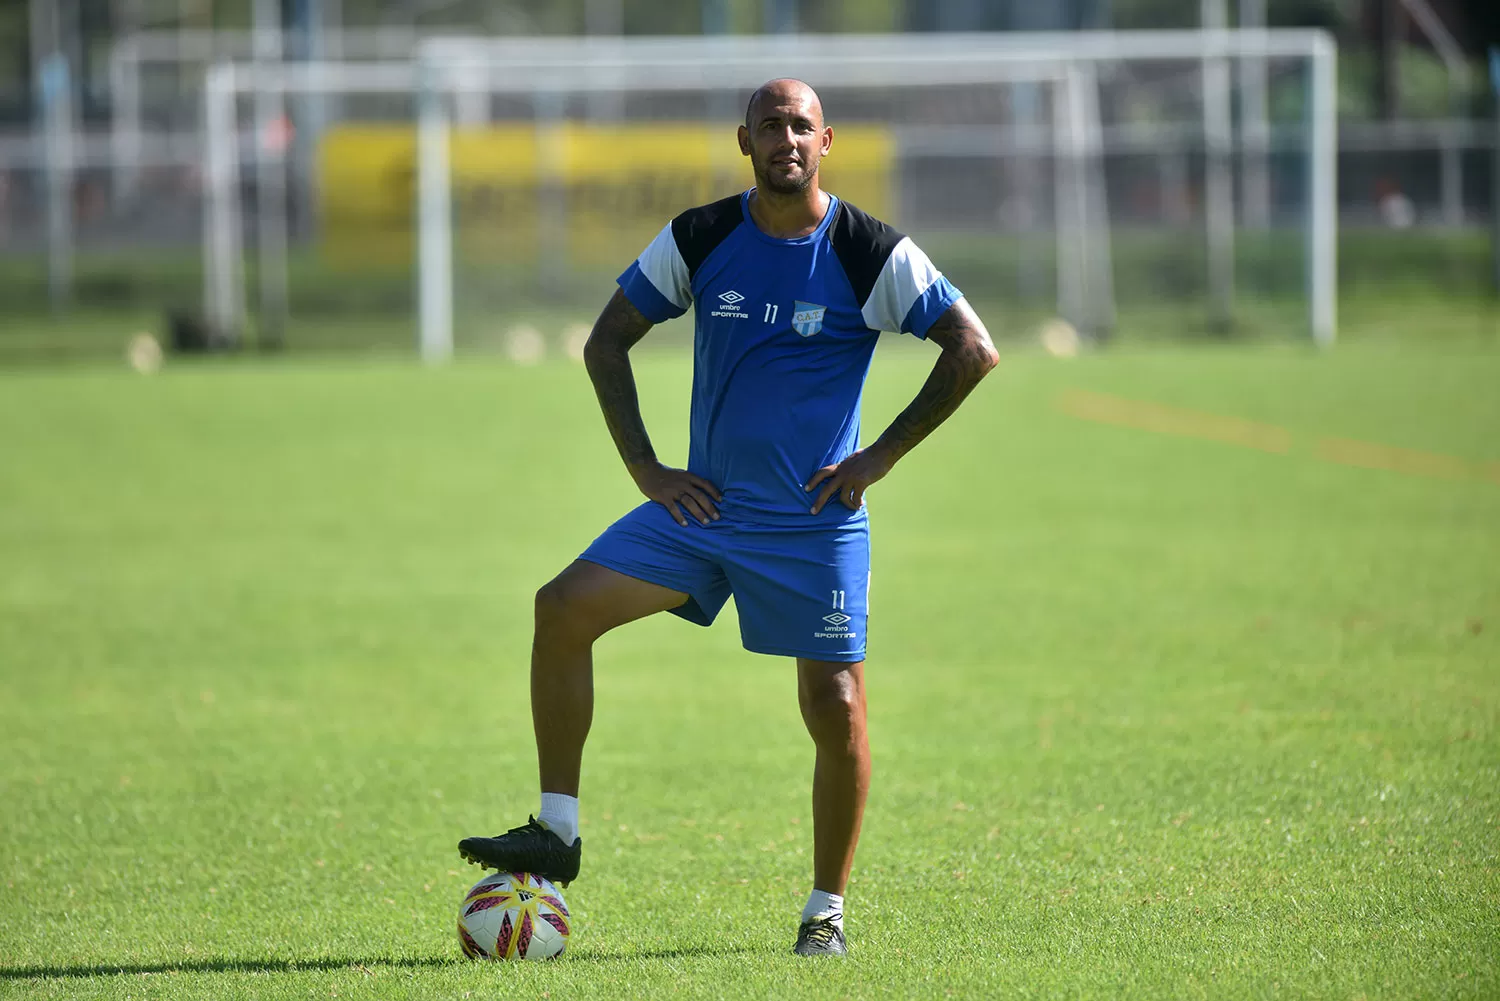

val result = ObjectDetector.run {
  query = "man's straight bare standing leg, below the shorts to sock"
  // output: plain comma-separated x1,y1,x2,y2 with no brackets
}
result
797,659,870,896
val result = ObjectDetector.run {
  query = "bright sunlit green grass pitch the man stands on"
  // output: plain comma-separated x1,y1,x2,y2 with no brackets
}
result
0,338,1500,999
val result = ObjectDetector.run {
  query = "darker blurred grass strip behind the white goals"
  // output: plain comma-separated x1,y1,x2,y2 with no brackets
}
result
0,227,1500,368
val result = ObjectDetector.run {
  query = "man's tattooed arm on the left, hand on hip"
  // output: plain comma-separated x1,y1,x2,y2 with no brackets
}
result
584,288,722,525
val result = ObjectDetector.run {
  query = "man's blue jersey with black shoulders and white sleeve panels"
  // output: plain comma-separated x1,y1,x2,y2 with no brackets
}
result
620,192,962,525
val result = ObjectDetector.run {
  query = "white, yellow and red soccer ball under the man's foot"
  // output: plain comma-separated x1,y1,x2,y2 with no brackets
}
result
459,872,573,959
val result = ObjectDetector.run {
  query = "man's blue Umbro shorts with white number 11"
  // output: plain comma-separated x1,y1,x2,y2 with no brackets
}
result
579,501,870,662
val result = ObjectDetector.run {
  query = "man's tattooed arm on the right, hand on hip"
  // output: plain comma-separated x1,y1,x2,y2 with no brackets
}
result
806,299,999,515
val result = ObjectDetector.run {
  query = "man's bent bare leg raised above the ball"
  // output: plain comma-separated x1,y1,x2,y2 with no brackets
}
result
531,560,687,795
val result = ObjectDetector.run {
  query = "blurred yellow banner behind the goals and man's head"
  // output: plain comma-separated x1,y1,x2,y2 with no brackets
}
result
318,123,894,269
